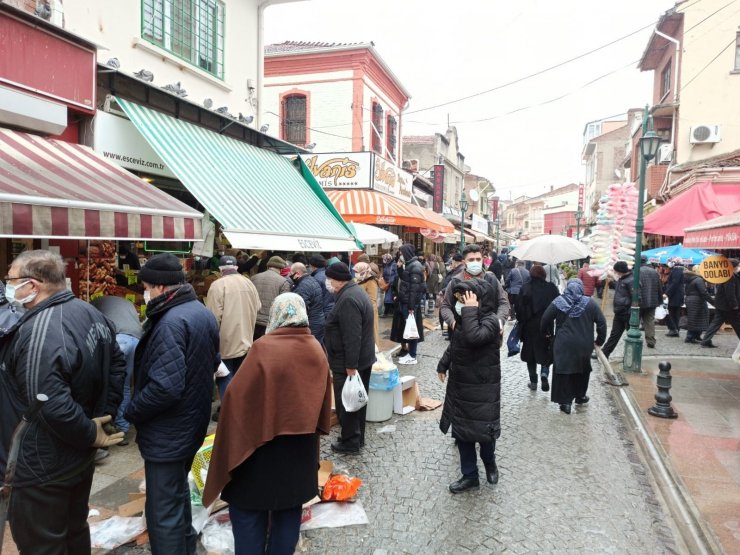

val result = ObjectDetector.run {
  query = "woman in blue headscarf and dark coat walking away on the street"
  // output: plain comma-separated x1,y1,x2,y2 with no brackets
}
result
541,278,606,414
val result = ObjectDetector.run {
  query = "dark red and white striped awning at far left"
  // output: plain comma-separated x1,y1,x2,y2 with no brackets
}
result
0,128,203,241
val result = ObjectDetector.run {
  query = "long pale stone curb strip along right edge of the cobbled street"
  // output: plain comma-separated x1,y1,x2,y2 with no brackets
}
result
611,364,725,555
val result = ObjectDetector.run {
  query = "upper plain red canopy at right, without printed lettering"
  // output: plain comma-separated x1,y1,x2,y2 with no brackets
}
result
644,181,740,237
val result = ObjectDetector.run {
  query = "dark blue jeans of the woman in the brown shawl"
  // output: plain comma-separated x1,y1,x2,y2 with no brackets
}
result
229,505,301,555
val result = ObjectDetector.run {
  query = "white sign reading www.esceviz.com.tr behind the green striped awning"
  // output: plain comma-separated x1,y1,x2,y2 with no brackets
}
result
93,110,177,179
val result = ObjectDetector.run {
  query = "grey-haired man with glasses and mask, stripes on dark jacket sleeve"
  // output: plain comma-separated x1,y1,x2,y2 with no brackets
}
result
0,250,126,553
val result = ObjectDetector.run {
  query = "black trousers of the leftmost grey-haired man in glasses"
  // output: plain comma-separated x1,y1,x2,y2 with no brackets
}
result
8,462,95,555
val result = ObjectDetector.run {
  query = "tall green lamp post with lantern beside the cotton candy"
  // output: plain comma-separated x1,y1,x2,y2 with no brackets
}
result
624,106,660,372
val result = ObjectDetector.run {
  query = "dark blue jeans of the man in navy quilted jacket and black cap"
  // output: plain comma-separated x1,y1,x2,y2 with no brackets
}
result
144,458,197,555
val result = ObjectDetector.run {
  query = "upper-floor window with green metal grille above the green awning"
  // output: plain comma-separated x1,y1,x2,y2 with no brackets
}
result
141,0,225,79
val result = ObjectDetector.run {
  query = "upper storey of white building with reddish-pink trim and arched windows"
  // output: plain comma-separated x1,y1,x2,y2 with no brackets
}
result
264,41,409,156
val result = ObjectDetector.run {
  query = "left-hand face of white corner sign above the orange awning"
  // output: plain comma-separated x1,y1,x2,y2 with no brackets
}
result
304,152,372,189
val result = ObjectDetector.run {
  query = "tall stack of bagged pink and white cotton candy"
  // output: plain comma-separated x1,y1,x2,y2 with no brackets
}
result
590,183,639,276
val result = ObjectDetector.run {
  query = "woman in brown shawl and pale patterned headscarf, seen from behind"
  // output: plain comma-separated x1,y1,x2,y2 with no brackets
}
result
203,293,331,555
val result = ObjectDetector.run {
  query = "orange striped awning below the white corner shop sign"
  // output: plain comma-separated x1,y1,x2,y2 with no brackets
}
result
325,189,455,233
